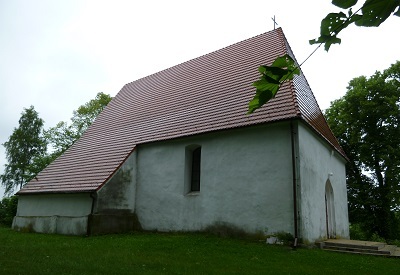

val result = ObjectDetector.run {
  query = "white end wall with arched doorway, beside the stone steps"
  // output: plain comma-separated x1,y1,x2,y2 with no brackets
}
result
297,122,349,241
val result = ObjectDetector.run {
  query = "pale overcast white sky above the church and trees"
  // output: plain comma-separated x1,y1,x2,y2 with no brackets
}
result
0,0,400,198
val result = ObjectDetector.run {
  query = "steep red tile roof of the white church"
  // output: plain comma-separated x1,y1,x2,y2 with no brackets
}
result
18,29,345,195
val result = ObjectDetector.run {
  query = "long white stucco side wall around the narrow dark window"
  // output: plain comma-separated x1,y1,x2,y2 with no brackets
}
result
136,123,293,234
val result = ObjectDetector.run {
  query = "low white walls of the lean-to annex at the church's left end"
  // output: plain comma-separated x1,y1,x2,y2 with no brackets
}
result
13,151,137,235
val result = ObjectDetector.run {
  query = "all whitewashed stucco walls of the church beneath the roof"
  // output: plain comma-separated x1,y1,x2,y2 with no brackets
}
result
13,122,349,242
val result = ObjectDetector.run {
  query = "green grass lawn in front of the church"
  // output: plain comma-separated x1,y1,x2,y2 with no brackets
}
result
0,227,400,275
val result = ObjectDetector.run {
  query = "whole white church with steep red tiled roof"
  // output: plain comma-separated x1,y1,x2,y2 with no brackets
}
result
13,28,349,242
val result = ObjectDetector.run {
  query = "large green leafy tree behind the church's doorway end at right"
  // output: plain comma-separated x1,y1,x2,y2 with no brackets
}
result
325,61,400,242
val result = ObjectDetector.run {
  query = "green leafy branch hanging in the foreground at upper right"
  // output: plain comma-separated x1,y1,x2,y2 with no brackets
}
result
248,0,400,114
